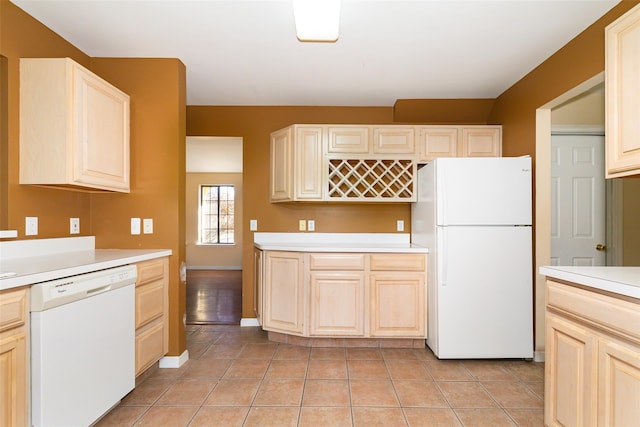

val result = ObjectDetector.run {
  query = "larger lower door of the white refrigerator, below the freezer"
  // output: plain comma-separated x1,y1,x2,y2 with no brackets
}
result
427,227,533,359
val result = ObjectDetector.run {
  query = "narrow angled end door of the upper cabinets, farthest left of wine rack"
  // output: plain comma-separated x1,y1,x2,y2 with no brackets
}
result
270,127,293,202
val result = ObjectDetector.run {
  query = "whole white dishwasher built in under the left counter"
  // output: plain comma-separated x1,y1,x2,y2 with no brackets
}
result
31,265,137,427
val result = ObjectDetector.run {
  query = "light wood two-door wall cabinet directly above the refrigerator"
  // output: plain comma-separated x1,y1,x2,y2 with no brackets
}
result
418,125,502,163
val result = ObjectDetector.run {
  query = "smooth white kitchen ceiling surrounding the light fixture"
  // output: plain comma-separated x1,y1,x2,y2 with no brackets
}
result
11,0,618,106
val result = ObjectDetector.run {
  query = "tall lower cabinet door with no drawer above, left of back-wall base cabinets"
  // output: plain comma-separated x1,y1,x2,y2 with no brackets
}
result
263,251,305,334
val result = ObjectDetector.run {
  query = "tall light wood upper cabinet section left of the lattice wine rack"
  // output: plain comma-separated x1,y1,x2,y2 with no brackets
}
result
270,125,323,202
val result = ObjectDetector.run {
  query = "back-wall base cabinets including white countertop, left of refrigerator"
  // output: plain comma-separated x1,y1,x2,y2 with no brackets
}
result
254,233,428,347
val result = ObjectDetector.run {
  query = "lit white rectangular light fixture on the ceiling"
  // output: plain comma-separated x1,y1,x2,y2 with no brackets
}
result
291,0,340,42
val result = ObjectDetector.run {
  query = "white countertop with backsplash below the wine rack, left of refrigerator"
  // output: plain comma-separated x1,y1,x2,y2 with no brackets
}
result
253,233,429,253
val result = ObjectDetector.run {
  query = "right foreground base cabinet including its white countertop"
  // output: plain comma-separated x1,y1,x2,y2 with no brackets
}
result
540,266,640,426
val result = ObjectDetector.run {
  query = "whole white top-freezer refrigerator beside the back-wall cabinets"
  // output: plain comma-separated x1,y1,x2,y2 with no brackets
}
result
411,157,533,359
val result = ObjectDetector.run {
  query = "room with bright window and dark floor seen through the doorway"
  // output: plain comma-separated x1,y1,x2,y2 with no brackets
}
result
185,136,243,324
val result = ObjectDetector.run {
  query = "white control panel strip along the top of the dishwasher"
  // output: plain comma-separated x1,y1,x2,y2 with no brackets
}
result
31,265,138,311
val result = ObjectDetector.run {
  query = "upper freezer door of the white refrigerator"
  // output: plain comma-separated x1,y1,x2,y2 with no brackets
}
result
434,157,531,225
